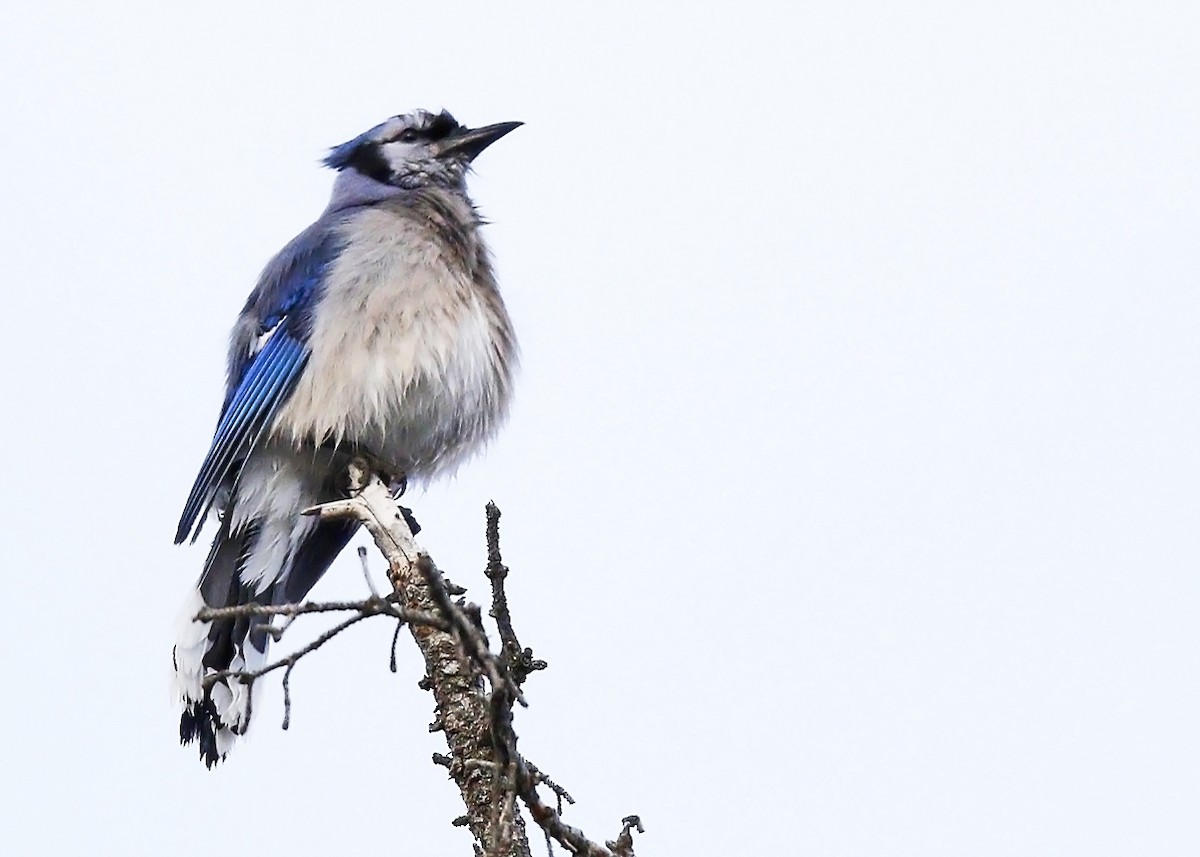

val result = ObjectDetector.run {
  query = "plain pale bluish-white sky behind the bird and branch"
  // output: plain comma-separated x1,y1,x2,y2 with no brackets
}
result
0,0,1200,857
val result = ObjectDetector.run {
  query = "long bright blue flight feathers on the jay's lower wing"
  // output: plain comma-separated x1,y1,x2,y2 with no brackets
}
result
175,323,308,545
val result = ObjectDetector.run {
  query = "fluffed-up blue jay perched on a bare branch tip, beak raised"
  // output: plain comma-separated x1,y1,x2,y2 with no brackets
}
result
174,110,521,767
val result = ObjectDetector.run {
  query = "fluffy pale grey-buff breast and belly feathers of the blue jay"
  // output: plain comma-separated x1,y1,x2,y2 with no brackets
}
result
272,196,516,480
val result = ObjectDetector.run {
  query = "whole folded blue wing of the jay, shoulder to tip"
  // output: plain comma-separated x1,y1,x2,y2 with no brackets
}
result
175,221,342,545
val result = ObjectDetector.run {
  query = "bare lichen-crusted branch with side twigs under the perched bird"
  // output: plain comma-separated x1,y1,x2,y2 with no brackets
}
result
222,459,642,857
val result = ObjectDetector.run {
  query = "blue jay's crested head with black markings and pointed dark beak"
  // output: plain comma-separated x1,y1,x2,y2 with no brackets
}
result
325,110,521,190
